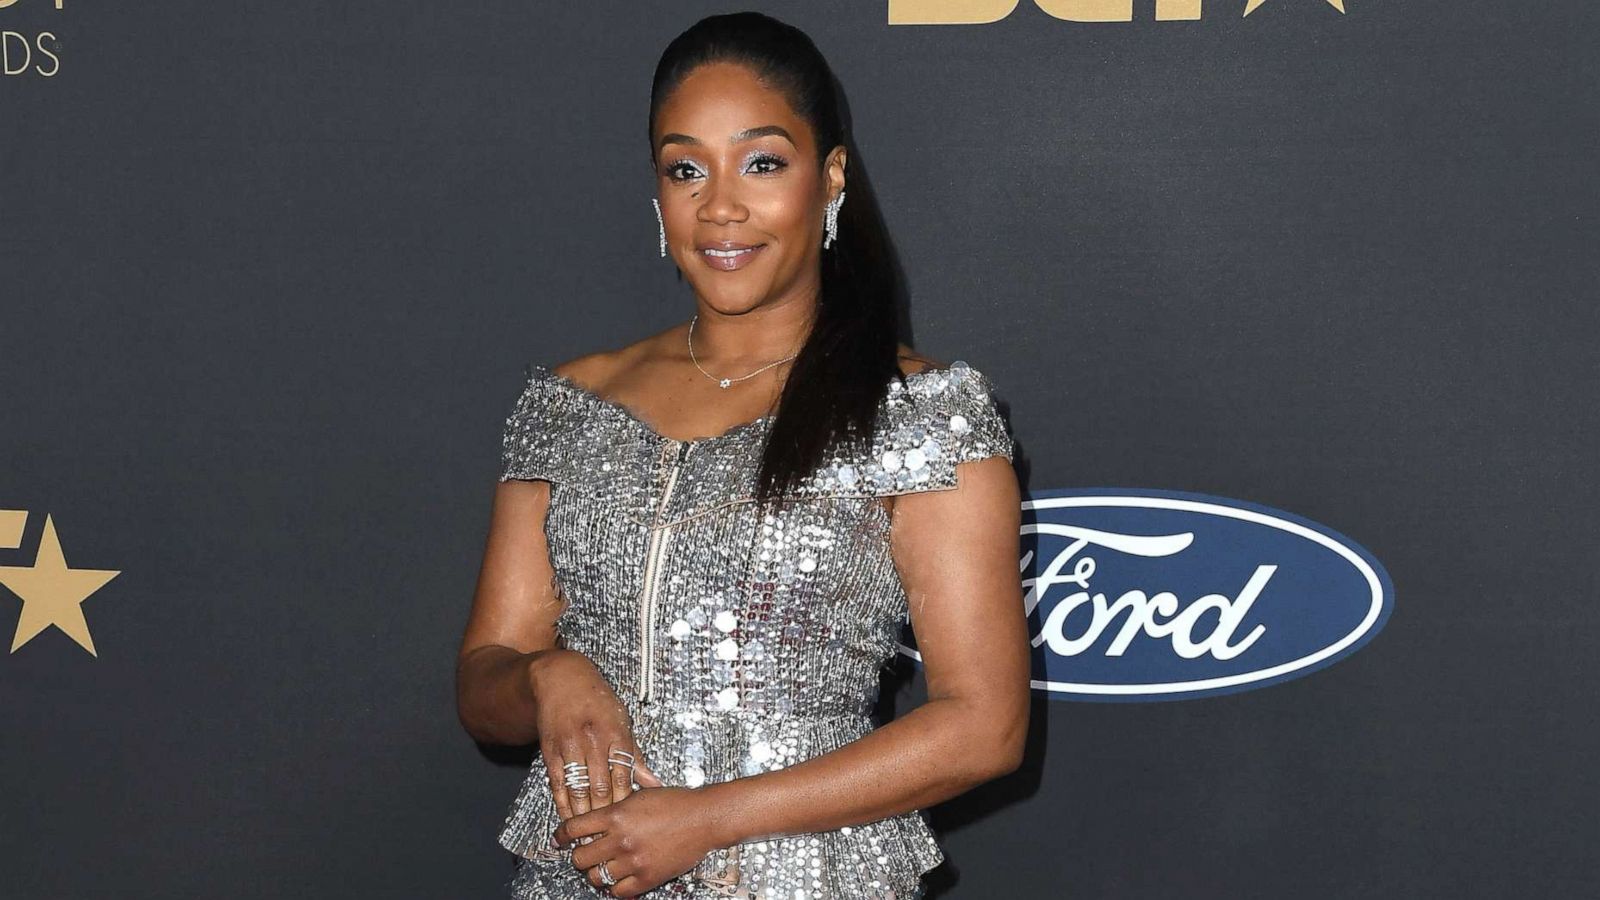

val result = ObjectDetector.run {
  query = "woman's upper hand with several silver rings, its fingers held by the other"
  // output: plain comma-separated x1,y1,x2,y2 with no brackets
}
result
528,649,662,820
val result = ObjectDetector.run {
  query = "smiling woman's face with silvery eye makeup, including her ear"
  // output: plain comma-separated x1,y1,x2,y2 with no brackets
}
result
651,62,845,315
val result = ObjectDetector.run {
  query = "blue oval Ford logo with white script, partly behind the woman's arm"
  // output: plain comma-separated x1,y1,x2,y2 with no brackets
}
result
902,488,1394,701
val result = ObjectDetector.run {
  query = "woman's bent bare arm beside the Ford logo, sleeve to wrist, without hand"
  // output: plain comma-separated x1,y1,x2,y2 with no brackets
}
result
699,458,1030,847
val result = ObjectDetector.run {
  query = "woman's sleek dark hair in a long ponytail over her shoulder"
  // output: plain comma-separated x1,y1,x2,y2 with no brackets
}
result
650,13,902,503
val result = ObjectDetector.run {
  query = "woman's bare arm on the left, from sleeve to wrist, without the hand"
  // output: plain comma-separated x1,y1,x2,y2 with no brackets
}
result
456,480,562,745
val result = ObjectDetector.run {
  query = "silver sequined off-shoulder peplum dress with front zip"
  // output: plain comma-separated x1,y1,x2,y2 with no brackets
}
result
499,353,1013,900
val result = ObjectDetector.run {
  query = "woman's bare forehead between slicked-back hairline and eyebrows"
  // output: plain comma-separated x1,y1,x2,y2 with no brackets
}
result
651,62,811,149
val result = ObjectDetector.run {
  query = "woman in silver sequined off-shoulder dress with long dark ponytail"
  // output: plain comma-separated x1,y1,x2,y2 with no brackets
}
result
458,13,1029,900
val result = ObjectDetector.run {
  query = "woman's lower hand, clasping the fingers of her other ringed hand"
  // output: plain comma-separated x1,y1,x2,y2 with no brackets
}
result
555,786,722,897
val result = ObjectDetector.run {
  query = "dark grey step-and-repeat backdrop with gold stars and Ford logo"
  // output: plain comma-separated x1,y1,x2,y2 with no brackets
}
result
0,0,1600,900
